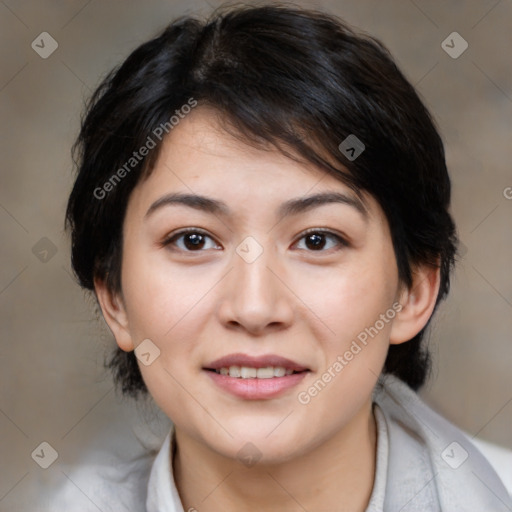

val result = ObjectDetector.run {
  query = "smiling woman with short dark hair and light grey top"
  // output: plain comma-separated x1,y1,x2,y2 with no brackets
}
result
67,4,512,512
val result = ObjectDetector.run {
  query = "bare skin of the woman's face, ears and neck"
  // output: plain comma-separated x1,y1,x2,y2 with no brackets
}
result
96,107,439,512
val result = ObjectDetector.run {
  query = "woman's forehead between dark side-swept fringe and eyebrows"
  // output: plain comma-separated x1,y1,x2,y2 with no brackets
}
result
128,107,379,225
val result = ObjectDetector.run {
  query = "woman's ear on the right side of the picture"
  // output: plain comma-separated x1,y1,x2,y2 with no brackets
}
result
389,265,440,345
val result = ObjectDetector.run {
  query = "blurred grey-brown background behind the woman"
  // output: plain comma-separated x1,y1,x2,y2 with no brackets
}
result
0,0,512,511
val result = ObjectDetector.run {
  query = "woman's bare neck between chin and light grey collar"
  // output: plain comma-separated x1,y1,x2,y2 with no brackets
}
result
173,402,377,512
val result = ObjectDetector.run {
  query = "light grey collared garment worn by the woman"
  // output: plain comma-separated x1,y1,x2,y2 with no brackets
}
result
48,375,512,512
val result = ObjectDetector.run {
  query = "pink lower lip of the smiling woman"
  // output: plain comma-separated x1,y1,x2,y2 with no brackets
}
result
204,370,309,400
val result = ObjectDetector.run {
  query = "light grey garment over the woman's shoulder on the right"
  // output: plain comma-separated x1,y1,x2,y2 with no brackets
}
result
373,375,512,511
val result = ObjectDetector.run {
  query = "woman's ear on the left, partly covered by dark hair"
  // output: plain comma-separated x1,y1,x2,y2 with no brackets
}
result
94,278,135,352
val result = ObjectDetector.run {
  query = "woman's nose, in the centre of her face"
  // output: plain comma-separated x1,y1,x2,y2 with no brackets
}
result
218,241,294,335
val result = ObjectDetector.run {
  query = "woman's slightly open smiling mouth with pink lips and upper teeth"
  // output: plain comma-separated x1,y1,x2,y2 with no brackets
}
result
203,354,311,400
